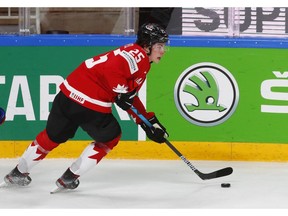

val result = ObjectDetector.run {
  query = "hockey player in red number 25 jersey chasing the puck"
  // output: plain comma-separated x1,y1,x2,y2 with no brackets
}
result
4,23,168,189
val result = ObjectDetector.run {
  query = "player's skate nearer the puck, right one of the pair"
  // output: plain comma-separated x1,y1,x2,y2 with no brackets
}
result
56,168,80,189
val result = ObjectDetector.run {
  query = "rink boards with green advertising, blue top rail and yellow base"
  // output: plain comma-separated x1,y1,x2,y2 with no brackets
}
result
0,35,288,160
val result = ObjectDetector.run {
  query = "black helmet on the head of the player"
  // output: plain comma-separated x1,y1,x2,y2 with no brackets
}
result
136,23,169,47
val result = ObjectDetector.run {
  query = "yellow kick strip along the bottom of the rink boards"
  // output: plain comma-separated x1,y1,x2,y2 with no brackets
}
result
0,141,288,162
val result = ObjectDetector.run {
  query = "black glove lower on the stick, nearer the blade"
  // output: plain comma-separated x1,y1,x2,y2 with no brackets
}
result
140,116,169,143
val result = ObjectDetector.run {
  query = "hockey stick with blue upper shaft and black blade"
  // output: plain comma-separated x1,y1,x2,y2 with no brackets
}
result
131,106,233,180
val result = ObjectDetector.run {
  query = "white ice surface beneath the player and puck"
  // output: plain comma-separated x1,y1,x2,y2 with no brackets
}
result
0,159,288,216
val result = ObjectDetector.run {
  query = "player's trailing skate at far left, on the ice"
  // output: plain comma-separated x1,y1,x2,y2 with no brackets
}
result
4,166,32,186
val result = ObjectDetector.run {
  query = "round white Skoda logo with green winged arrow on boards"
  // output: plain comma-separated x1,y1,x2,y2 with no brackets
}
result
174,62,239,126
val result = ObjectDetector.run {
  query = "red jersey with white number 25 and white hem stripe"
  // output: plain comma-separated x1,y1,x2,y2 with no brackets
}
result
60,44,154,122
